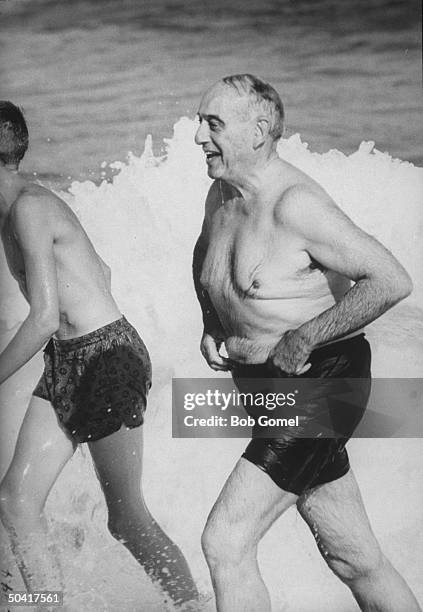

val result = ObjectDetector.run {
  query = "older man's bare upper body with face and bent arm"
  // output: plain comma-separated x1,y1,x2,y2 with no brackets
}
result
194,83,411,373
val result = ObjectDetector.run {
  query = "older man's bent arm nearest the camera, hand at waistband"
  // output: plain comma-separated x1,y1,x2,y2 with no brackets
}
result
269,187,412,373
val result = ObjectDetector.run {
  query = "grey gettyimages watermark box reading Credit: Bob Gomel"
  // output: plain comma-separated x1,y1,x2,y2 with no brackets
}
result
172,377,423,438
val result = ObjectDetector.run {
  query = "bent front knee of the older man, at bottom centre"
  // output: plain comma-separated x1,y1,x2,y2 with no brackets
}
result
201,520,256,569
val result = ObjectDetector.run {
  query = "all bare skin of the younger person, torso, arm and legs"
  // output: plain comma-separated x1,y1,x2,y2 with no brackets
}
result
0,164,198,605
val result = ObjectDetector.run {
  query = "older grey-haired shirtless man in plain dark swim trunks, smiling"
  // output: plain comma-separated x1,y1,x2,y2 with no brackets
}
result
193,74,420,612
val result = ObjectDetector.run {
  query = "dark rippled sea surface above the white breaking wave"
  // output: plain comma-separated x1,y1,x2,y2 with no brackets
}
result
0,0,423,184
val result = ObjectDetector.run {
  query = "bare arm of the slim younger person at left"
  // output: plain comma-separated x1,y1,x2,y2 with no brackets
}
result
0,197,59,384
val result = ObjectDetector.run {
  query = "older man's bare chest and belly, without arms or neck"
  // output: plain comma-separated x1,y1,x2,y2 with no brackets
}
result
200,169,351,363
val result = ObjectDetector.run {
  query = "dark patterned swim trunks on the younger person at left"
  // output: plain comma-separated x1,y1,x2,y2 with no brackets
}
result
33,317,151,443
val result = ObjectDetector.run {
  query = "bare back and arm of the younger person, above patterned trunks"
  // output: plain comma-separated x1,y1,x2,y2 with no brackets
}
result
0,170,121,384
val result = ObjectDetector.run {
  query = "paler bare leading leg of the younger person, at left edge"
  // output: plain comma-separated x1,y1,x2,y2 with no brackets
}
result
0,397,74,591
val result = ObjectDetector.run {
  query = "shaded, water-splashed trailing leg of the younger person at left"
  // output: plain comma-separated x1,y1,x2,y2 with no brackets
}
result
89,426,198,604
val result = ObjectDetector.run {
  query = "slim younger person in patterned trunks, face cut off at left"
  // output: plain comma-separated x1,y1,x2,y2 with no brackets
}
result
0,101,197,604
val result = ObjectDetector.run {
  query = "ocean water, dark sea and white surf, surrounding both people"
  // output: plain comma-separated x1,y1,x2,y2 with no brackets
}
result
0,0,423,612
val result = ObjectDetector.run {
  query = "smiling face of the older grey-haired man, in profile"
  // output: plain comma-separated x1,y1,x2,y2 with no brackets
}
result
195,83,255,180
